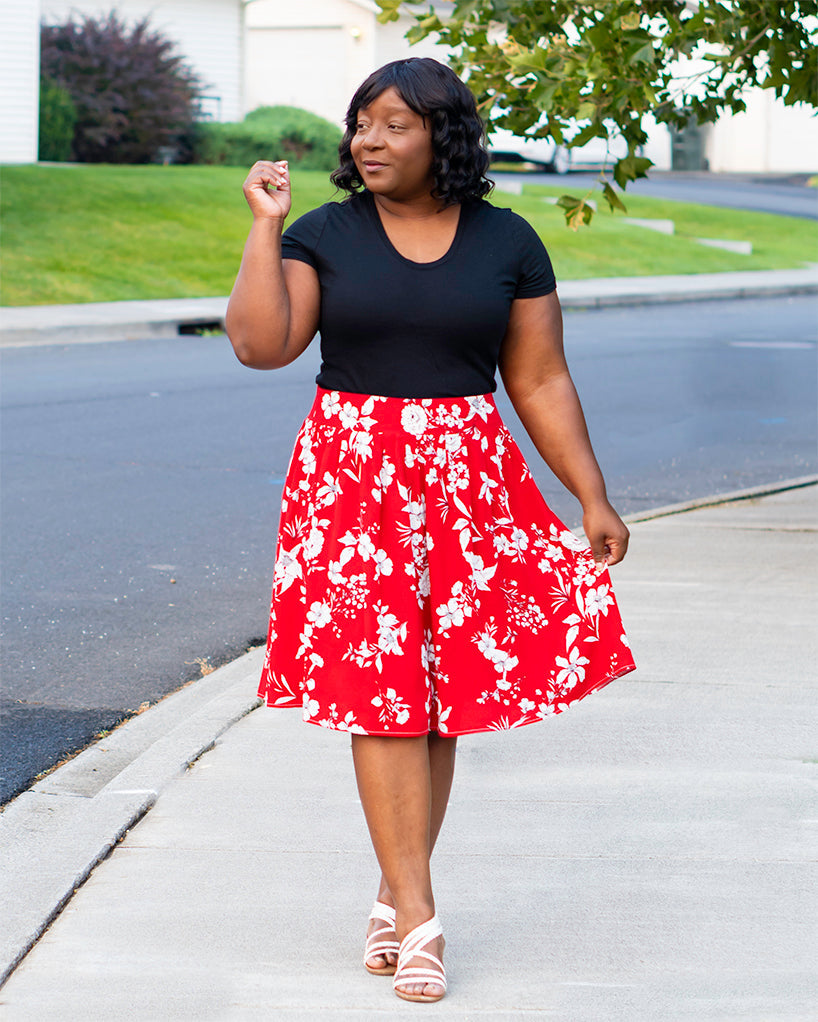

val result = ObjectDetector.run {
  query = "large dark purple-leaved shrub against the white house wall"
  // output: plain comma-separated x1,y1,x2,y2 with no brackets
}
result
41,12,198,164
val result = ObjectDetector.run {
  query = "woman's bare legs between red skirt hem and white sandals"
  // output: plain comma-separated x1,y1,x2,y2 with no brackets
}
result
352,735,456,994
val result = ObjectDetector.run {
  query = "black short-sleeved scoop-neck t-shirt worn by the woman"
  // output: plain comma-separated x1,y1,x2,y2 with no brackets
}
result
281,191,556,398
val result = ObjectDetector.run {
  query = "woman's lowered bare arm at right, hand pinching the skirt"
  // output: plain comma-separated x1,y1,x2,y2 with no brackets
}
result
499,292,629,565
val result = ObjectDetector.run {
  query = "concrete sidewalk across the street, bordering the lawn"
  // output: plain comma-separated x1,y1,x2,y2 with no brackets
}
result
0,266,818,347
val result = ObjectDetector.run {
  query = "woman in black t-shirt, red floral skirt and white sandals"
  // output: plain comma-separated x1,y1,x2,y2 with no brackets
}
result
226,58,633,1001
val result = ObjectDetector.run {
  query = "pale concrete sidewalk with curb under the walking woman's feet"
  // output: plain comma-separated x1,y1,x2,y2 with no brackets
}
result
0,485,818,1022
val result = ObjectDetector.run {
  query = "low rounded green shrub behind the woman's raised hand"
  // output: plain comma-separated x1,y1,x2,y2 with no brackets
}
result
193,106,340,171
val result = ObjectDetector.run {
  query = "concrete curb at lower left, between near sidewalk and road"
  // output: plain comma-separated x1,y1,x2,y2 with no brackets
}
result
0,647,264,986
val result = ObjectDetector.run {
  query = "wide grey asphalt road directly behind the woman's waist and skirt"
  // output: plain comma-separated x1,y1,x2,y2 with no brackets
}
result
0,297,818,800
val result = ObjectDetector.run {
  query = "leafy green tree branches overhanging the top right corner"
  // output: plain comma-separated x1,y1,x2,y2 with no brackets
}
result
377,0,818,230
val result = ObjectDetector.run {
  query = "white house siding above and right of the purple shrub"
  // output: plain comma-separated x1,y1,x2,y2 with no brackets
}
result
41,0,244,121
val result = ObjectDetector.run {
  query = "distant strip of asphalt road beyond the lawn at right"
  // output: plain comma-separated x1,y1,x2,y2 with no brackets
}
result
493,171,818,220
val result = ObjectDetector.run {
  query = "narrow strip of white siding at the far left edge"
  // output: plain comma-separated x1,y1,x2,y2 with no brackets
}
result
0,0,40,164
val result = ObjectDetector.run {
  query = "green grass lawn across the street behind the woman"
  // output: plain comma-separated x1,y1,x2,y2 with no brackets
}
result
0,165,818,306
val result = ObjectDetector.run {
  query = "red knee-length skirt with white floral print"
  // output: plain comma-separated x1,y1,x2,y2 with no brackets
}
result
259,387,634,735
